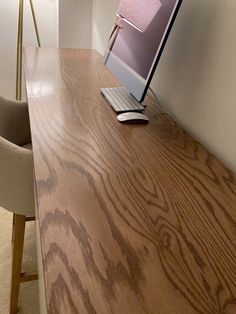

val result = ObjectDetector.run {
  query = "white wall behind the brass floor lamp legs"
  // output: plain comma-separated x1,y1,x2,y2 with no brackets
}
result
0,0,58,98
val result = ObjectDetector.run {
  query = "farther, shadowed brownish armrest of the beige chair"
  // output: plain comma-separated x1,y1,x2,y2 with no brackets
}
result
0,96,31,146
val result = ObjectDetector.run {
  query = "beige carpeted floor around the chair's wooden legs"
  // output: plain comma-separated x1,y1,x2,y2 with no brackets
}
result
0,208,39,314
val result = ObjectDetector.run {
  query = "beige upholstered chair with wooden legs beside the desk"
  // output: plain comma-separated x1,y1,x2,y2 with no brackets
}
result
0,96,37,314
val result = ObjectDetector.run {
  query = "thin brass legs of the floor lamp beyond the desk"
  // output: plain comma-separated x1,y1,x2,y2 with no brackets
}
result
16,0,41,100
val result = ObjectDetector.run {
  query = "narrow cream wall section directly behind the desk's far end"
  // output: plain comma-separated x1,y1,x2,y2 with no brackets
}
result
59,0,93,48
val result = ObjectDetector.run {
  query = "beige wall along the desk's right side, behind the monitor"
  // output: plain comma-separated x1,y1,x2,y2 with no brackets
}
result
92,0,236,172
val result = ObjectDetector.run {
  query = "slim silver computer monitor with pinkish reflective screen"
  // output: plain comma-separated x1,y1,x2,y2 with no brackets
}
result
104,0,182,102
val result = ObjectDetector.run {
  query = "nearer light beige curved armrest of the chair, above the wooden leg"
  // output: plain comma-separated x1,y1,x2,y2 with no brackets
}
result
0,137,34,216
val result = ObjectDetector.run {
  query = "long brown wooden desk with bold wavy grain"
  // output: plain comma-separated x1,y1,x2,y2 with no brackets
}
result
25,48,236,314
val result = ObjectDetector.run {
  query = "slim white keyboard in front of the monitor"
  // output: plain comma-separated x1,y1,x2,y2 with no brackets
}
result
101,87,145,113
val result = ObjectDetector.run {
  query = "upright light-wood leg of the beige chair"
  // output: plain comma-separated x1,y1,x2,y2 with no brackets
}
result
10,215,25,314
